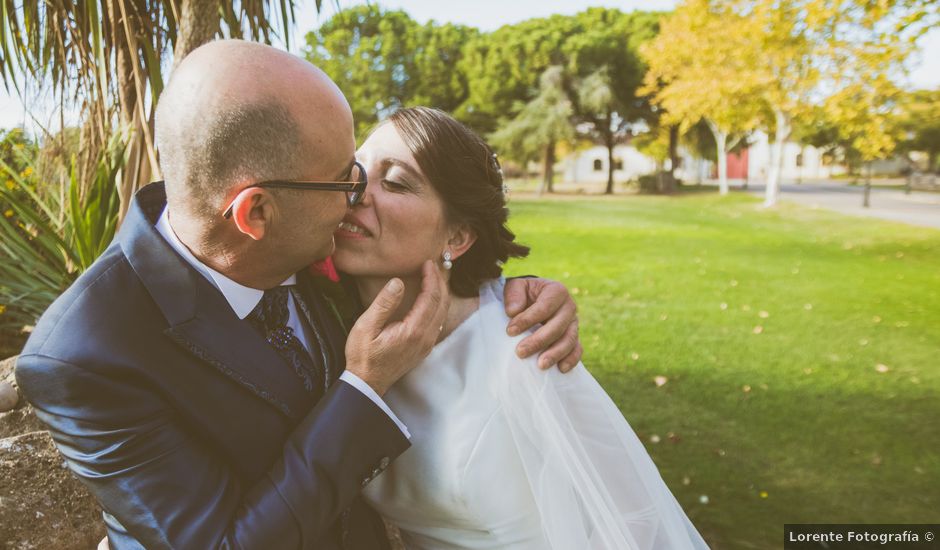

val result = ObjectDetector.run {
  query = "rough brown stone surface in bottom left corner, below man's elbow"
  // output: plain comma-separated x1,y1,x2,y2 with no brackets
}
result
0,434,105,550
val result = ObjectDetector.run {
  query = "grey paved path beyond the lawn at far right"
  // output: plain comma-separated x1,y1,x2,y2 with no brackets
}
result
748,181,940,229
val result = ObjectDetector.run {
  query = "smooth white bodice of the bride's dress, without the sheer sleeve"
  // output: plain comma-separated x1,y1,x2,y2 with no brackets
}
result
364,282,546,550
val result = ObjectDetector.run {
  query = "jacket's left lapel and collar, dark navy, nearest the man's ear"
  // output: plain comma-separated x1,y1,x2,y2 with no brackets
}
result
117,184,310,421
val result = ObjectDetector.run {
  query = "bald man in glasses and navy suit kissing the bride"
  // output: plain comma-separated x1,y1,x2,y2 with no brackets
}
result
16,41,580,550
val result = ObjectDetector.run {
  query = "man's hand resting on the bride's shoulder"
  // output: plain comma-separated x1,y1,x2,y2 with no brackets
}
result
504,278,584,372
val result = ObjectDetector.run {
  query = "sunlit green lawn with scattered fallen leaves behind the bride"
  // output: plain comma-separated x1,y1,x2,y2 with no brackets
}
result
507,194,940,548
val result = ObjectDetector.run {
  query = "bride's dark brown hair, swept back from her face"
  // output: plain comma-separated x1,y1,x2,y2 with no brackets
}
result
388,107,529,297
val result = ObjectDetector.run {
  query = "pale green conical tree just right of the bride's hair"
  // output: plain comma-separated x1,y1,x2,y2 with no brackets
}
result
490,65,575,193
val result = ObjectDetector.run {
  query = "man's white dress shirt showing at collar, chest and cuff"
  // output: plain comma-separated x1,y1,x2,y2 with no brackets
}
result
156,208,411,439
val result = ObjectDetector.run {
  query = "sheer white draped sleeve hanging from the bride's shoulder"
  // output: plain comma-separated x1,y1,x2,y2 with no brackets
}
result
492,337,708,550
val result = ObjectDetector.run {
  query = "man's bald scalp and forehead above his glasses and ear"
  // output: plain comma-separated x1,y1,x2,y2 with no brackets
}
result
156,40,354,220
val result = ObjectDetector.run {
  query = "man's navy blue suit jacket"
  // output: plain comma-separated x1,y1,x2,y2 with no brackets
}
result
16,185,408,550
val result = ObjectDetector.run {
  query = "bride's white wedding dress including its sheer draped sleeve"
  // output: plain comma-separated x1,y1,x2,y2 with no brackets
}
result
364,281,707,550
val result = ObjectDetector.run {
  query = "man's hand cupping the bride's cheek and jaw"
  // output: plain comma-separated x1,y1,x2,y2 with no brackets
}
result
346,260,450,395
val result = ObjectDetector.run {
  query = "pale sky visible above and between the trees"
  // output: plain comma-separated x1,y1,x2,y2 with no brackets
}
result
0,0,940,132
